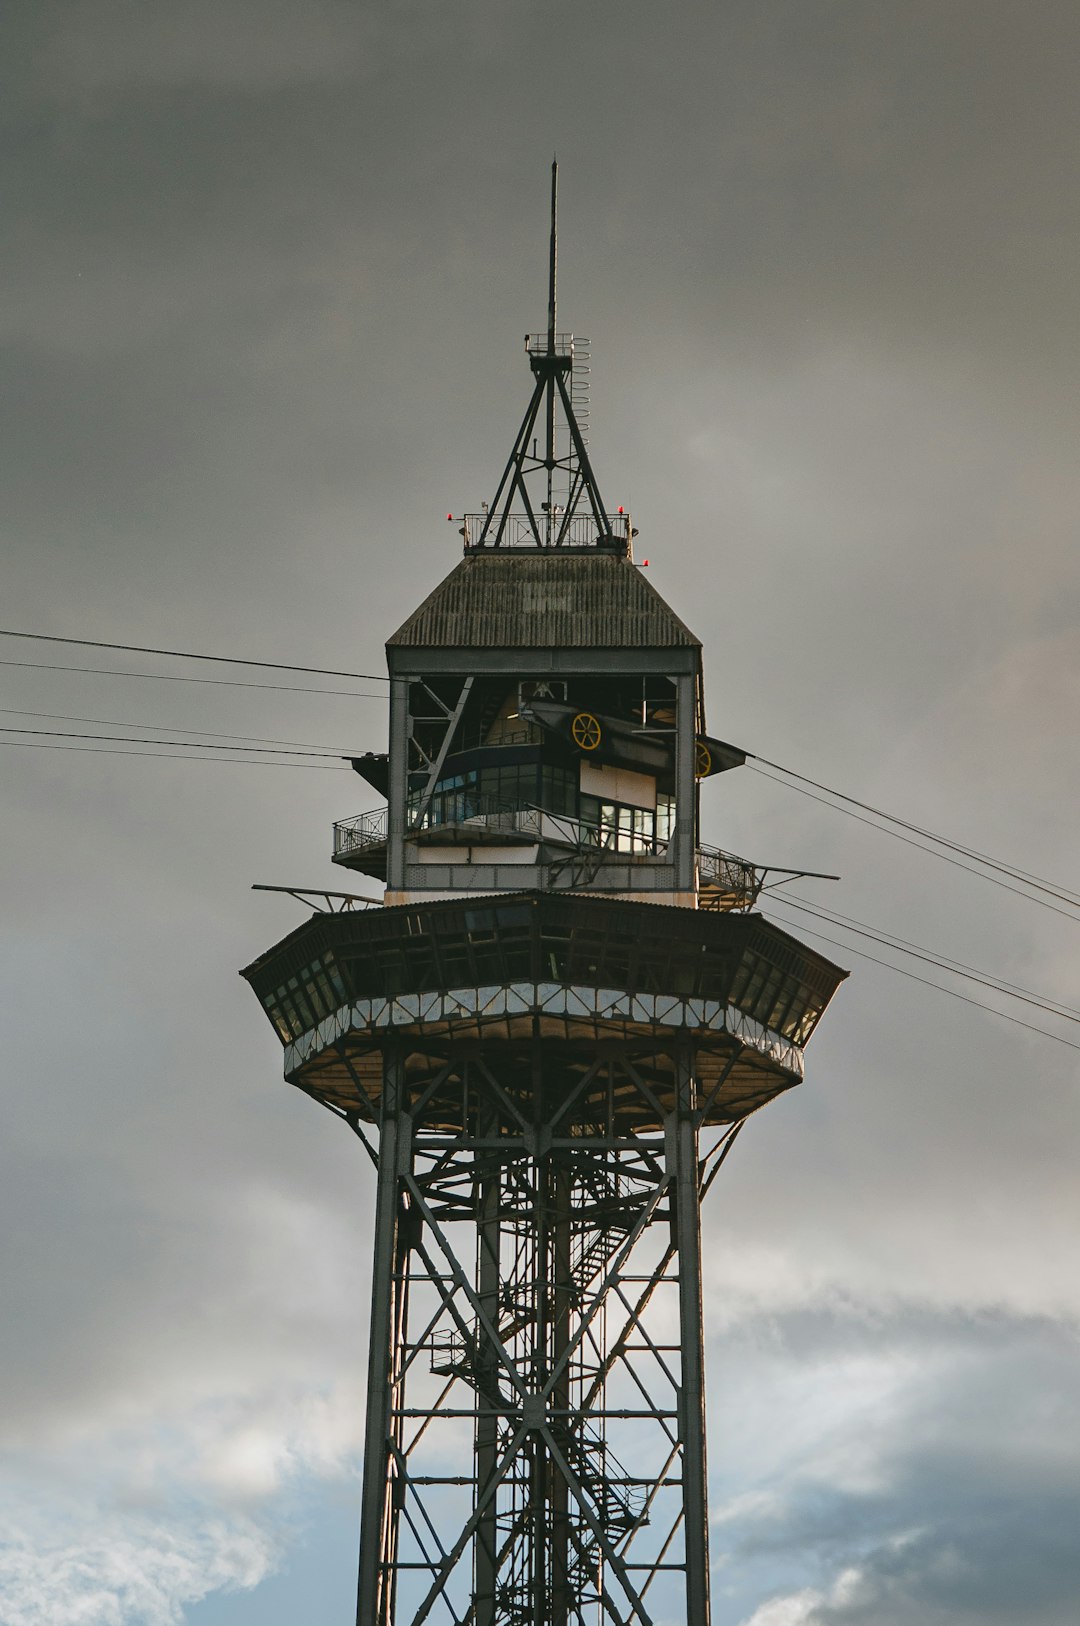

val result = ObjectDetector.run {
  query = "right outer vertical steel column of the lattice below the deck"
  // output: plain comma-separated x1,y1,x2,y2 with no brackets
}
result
667,1037,709,1626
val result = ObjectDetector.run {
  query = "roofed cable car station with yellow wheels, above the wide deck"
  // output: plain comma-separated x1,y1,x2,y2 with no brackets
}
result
333,550,743,904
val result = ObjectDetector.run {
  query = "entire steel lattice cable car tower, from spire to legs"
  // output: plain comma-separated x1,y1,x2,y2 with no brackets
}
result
244,167,844,1626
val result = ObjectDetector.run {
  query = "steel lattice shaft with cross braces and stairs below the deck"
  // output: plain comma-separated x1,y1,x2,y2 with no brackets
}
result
346,1039,742,1626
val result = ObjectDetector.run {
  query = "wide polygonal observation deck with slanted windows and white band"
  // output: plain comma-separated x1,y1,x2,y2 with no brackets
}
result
242,893,846,1135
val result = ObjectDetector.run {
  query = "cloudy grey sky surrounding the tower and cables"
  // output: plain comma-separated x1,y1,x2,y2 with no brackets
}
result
0,0,1080,1626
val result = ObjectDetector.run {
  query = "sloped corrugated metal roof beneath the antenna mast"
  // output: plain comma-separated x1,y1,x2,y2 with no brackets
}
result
387,548,701,649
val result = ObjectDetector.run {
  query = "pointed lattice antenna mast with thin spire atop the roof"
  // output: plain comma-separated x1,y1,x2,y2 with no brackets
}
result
462,163,624,556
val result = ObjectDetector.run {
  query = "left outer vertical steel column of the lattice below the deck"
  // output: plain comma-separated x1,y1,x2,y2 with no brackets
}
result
356,1052,412,1626
